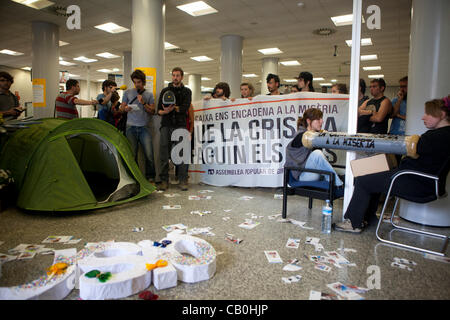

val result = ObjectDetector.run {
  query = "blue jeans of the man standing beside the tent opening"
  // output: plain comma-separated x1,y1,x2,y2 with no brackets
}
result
126,126,155,179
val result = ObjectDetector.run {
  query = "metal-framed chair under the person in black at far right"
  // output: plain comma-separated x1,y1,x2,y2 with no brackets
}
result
376,158,450,256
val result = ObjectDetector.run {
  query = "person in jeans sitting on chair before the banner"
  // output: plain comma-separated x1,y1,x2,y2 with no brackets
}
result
285,108,344,188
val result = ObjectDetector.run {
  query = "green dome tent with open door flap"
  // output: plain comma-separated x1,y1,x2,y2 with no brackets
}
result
0,118,155,211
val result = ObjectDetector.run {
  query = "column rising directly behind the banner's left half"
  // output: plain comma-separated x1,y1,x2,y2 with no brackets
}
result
220,35,243,98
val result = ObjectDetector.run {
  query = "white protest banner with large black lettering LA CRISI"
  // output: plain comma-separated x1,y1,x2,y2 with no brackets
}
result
191,92,349,188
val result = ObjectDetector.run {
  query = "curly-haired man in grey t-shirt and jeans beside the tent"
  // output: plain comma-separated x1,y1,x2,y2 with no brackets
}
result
119,69,155,183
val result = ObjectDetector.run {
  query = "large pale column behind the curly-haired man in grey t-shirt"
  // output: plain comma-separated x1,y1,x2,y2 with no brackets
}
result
130,0,166,181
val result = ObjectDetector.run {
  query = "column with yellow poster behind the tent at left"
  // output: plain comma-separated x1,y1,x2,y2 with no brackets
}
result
31,21,59,119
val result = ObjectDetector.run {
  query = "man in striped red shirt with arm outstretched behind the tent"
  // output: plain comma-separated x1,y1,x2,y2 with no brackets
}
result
55,79,98,119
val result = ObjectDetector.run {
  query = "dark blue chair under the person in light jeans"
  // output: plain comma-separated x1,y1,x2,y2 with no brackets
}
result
282,166,344,219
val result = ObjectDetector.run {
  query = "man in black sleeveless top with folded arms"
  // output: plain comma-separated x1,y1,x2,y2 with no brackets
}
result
358,78,392,134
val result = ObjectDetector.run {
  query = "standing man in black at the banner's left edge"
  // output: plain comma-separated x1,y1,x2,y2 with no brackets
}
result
158,67,192,191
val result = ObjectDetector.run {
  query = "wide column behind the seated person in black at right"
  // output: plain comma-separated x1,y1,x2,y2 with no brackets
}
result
400,0,450,226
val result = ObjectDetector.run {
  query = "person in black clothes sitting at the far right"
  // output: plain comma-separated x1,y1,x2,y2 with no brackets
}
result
333,98,450,233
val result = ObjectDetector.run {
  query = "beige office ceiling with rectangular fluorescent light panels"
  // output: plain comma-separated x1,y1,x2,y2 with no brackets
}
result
0,0,411,87
